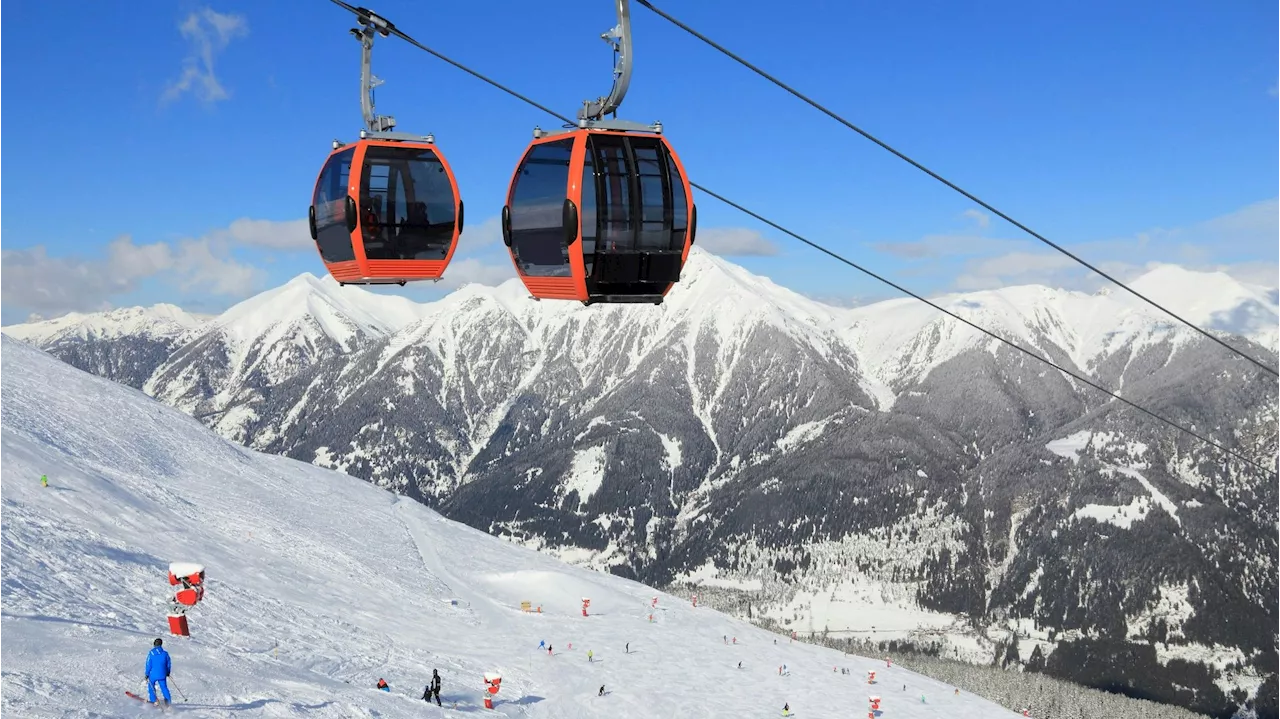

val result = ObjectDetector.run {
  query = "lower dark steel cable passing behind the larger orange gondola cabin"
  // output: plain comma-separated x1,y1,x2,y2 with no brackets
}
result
314,0,1275,477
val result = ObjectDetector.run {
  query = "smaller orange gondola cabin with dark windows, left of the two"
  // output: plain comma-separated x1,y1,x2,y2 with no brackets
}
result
308,139,463,285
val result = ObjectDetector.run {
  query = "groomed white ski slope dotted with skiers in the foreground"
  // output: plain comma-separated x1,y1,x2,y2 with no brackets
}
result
0,335,1015,719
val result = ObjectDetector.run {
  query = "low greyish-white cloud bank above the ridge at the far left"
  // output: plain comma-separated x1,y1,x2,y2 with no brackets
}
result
0,235,262,316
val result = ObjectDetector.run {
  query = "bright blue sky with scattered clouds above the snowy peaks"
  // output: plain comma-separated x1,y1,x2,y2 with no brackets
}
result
0,0,1280,322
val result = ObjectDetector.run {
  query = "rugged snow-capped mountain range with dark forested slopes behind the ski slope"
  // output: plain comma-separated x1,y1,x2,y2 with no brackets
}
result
4,251,1280,716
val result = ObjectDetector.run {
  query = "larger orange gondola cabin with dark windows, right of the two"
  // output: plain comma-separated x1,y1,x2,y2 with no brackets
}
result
502,129,698,304
